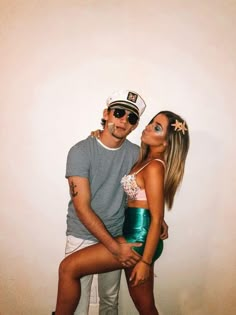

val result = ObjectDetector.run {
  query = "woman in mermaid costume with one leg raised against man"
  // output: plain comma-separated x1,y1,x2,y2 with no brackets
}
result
56,111,189,315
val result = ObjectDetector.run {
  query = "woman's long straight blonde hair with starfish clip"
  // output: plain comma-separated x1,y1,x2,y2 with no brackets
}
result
137,110,189,210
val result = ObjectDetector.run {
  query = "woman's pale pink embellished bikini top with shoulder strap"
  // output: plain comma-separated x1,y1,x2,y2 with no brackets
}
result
121,159,165,200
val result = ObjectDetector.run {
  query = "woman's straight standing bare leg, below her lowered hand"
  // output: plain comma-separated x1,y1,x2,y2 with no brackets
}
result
125,266,159,315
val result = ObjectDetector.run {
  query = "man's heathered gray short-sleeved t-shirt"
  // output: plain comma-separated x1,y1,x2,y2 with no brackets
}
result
66,137,139,241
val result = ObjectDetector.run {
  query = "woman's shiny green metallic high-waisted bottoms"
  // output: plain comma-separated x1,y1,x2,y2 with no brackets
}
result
123,208,163,263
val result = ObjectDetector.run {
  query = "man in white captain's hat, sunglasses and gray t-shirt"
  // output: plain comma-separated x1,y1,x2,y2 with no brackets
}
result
61,90,168,315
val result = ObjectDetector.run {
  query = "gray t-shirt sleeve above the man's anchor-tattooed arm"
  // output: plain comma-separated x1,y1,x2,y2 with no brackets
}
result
65,143,90,178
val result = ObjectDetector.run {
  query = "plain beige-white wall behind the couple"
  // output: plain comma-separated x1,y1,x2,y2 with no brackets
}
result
0,0,236,315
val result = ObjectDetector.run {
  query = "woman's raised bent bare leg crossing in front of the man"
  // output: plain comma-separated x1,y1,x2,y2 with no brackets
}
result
56,243,122,315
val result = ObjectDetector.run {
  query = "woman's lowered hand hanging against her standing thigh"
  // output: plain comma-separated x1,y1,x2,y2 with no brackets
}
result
129,260,152,286
